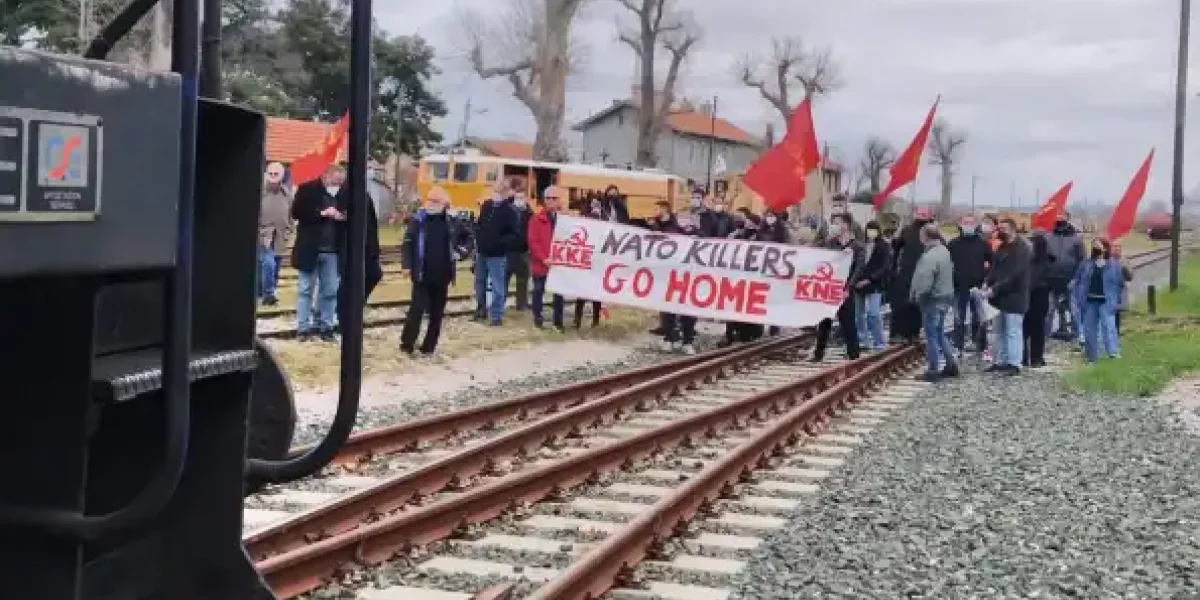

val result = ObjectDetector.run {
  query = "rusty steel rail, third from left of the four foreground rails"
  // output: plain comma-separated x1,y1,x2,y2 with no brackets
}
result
257,347,917,599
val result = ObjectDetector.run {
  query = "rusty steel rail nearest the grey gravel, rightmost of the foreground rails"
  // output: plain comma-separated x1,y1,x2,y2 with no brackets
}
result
526,346,919,600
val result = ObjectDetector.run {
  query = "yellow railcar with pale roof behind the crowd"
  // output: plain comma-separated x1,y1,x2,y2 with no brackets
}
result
416,155,690,220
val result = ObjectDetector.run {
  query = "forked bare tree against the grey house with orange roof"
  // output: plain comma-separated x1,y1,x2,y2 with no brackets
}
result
617,0,700,167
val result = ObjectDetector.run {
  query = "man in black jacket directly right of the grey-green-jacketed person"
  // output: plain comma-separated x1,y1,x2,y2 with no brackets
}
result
946,216,992,353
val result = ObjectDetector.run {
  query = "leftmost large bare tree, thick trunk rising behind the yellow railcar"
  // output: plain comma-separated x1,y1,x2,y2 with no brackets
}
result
461,0,584,161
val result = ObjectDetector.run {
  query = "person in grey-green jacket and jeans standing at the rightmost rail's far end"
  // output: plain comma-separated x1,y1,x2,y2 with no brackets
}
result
908,223,959,382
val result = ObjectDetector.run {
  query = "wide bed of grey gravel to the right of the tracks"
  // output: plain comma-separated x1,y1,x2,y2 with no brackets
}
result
731,346,1200,600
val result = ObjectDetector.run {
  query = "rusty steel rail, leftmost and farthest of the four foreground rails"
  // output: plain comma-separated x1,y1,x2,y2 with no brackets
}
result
295,346,738,464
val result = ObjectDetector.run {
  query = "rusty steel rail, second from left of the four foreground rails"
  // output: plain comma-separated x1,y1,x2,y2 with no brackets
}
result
242,332,812,560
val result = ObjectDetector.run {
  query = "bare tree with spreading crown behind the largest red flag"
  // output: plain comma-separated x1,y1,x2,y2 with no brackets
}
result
737,36,844,121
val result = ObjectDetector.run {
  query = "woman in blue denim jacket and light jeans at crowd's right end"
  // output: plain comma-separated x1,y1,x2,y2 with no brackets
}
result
1072,238,1124,362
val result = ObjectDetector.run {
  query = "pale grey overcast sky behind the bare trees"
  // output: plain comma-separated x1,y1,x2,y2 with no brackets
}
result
374,0,1200,211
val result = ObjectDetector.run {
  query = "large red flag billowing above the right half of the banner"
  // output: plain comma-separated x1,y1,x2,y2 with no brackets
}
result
742,98,821,212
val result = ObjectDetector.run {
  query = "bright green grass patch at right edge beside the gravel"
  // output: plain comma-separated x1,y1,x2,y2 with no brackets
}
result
1067,258,1200,396
